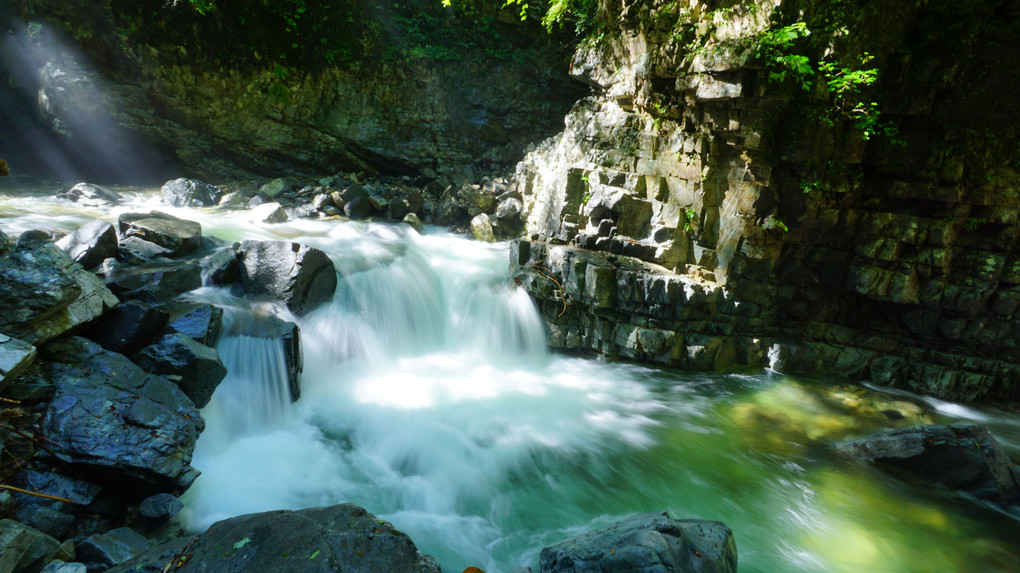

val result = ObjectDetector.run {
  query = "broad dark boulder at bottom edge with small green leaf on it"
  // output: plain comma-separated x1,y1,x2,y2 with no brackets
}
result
109,504,440,573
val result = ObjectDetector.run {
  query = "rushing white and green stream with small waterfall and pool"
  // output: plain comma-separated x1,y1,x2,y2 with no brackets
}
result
0,183,1020,573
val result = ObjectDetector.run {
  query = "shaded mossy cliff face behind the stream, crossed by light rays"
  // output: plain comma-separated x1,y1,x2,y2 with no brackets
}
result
0,0,583,179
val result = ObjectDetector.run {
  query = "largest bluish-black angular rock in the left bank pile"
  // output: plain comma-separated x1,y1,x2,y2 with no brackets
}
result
40,337,205,493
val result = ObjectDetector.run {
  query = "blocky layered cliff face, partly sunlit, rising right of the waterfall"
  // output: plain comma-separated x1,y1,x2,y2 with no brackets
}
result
514,0,1020,400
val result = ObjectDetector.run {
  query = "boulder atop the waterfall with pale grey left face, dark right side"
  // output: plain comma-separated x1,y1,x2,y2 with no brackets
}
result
238,241,337,314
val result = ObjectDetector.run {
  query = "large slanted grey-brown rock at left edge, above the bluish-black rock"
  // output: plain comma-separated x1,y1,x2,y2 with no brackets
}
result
0,236,119,346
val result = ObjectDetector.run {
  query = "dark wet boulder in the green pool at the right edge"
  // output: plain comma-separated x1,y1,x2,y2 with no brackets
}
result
837,424,1020,508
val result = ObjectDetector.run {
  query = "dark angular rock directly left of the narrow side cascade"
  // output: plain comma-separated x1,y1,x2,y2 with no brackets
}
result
132,332,226,408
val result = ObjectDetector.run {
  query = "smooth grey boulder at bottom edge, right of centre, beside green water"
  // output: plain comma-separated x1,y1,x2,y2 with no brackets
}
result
540,512,736,573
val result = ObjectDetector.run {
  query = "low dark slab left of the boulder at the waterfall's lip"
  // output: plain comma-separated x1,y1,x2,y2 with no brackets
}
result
106,261,203,304
